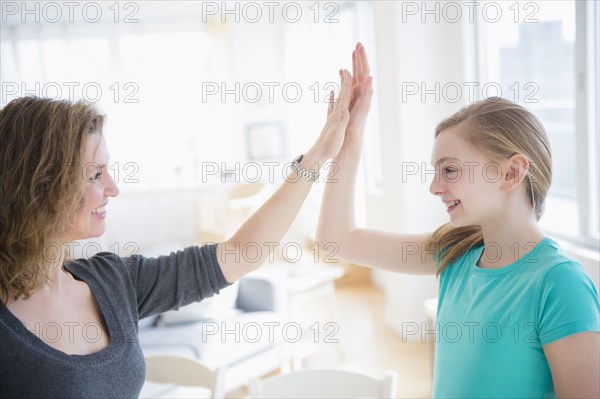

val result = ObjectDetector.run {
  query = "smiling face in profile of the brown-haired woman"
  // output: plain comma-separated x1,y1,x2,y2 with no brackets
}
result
66,133,119,242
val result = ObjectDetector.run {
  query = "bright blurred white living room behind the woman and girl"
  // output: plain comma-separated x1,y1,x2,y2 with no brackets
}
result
0,0,600,397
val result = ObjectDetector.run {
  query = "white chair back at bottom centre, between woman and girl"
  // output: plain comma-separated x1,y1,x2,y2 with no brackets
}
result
248,369,397,399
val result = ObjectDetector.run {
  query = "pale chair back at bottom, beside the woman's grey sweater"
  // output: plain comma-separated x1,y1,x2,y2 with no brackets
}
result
141,356,225,398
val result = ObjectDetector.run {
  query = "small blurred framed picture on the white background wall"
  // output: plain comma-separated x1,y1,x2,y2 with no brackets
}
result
246,122,286,160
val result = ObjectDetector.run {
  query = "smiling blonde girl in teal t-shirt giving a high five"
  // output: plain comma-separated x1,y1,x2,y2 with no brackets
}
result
316,45,600,398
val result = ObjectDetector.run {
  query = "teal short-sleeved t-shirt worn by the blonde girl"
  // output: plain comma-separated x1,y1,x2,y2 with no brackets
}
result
433,238,600,398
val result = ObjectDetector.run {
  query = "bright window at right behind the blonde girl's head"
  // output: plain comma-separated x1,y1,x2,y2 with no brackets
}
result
476,1,599,248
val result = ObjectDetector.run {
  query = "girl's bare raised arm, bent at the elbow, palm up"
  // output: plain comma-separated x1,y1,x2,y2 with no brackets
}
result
316,43,436,274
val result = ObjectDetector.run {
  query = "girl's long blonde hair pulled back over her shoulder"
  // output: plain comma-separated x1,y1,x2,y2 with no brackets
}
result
428,97,552,275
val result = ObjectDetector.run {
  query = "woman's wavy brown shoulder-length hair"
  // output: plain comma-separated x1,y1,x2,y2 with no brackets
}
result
0,97,104,302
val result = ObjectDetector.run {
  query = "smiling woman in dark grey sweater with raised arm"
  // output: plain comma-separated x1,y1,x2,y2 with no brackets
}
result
0,63,352,398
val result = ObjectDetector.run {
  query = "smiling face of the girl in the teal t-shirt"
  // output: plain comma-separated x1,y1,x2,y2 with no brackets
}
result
429,123,504,227
